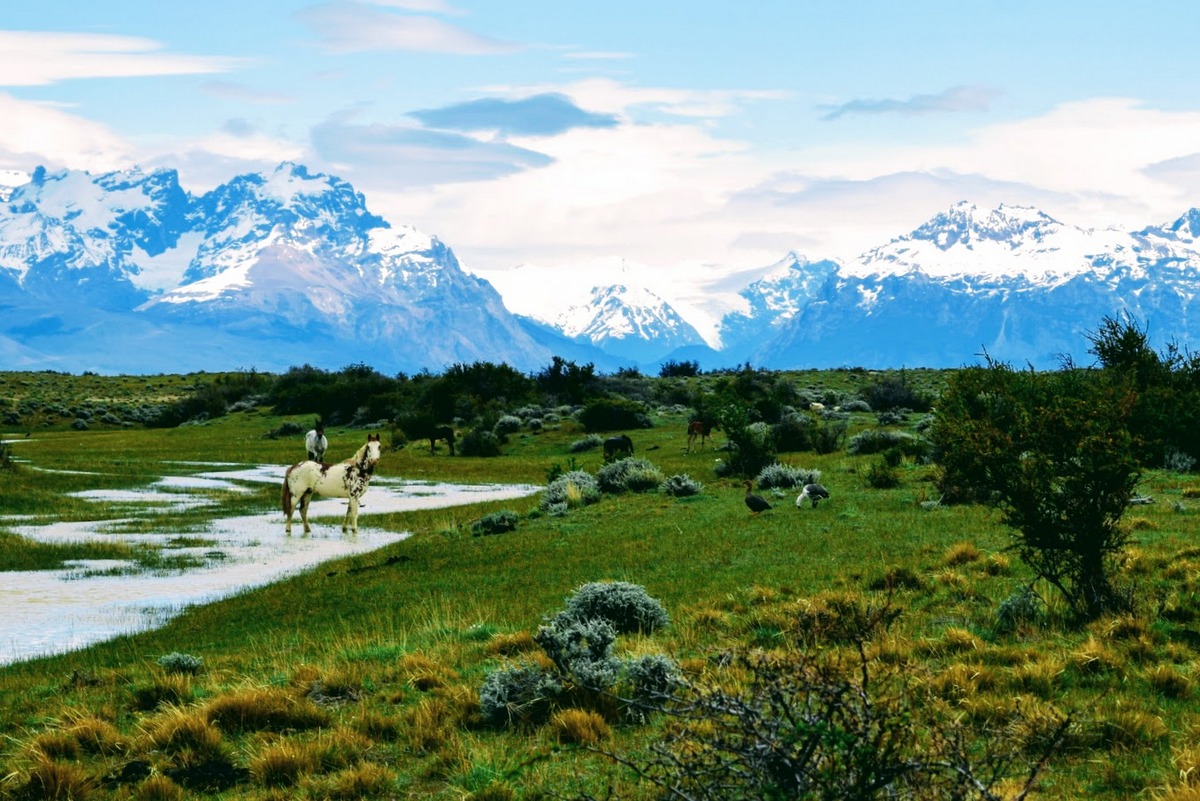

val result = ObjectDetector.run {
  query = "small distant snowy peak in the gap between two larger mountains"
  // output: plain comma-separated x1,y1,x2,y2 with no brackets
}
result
554,284,704,365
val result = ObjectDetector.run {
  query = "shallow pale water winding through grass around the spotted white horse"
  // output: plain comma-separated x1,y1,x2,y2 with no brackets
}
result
0,465,541,664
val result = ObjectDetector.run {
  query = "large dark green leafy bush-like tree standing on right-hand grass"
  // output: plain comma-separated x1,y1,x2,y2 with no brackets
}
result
931,360,1139,619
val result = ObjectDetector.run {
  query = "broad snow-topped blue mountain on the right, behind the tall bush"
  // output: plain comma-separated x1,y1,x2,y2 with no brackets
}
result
752,204,1200,367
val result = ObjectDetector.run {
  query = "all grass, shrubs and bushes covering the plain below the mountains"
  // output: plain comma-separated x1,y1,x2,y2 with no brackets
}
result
7,320,1200,800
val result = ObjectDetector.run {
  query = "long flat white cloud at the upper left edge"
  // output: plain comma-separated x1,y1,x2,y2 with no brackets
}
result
0,30,245,86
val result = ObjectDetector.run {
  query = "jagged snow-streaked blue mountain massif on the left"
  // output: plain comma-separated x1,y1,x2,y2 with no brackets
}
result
0,163,552,372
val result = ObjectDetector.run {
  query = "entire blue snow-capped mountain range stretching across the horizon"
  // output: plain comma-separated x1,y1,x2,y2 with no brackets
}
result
0,163,1200,373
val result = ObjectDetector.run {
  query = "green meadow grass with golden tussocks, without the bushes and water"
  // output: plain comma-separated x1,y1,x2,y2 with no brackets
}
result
0,371,1200,800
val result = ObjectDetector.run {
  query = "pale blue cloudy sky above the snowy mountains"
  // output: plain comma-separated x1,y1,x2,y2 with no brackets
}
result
0,0,1200,333
